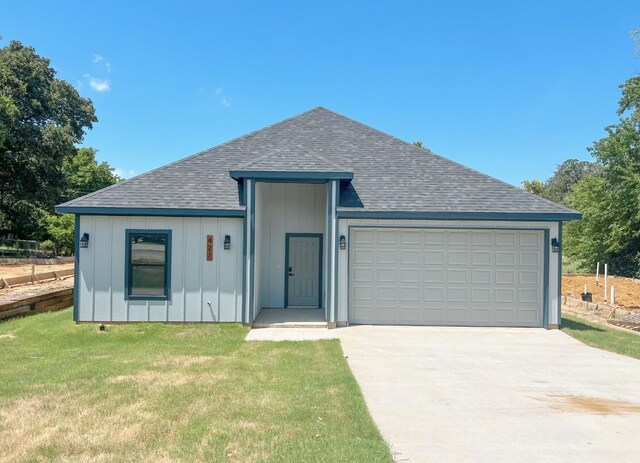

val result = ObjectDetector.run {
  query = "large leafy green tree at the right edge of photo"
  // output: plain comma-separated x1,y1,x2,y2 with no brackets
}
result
565,77,640,276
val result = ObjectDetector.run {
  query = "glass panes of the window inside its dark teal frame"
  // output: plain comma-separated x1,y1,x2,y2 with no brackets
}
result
129,233,167,296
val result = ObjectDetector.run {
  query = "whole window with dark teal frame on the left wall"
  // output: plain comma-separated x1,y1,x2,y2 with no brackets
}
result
126,230,171,299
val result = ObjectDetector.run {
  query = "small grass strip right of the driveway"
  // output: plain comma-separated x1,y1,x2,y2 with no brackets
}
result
562,314,640,359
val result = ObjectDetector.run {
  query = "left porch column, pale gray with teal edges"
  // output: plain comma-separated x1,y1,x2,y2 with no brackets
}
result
242,178,256,324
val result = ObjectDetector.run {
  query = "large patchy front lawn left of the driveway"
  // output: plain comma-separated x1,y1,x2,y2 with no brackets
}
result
0,310,392,462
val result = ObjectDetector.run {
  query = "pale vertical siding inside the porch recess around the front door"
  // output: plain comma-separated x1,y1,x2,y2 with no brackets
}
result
255,182,327,312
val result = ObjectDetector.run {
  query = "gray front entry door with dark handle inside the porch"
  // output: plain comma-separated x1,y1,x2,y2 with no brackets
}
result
285,233,322,308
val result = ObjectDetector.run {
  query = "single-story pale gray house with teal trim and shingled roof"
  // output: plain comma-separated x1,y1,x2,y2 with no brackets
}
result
56,107,580,328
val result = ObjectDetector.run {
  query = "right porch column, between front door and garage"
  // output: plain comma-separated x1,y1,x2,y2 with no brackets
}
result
326,180,340,328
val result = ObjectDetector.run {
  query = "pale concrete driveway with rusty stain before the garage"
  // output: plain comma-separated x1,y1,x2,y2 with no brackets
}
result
338,326,640,462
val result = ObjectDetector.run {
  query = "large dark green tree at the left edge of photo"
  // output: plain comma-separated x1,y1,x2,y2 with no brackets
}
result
0,41,97,236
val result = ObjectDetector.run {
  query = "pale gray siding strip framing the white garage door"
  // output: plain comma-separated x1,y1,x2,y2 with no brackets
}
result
337,219,560,325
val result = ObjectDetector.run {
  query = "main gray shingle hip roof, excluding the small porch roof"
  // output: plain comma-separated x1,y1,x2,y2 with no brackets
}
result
56,107,576,219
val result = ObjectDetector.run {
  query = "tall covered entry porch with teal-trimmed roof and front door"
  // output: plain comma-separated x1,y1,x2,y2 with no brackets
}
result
230,152,353,328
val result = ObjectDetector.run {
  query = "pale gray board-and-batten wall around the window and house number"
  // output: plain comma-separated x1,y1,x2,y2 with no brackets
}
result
76,215,243,322
